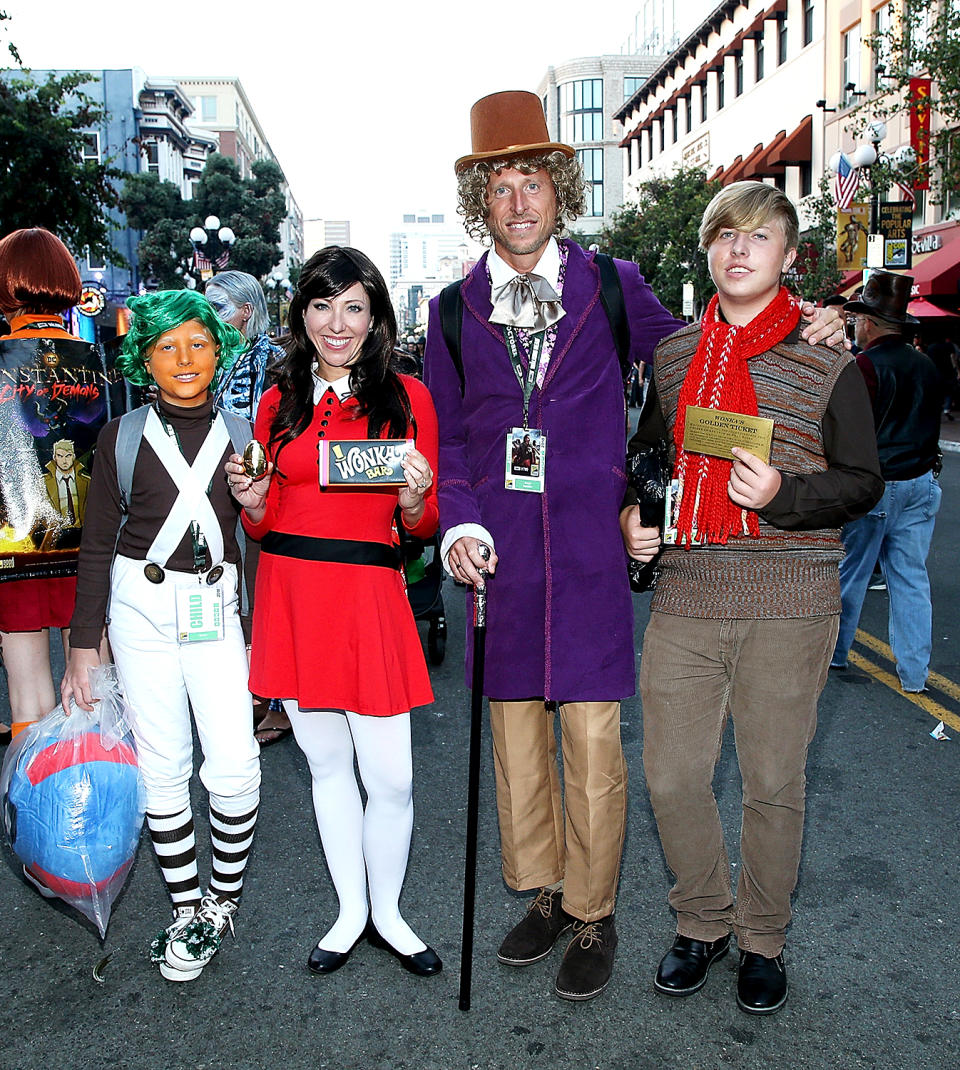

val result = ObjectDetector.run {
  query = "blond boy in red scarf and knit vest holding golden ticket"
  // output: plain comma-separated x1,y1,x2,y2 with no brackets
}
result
621,182,883,1014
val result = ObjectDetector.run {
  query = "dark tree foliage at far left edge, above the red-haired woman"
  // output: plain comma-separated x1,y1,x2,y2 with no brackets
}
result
0,70,125,265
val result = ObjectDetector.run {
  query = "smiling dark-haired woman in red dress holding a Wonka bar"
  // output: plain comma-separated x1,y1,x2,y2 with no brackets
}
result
226,246,441,976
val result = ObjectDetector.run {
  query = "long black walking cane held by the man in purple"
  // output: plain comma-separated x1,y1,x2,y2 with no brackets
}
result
460,542,490,1010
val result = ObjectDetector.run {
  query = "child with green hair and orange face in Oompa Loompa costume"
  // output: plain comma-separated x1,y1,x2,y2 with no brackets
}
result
61,290,260,981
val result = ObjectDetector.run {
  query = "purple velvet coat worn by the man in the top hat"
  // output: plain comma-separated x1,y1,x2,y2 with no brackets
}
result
424,241,683,702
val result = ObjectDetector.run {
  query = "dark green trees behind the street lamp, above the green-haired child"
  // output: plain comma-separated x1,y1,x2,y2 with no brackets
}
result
122,153,286,289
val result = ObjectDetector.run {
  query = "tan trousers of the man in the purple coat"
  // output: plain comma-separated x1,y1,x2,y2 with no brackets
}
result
490,699,627,921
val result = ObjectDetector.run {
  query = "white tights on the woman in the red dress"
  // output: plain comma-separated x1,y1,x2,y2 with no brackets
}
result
284,699,426,954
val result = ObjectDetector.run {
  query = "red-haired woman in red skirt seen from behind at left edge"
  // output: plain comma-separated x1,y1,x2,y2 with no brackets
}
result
0,227,89,742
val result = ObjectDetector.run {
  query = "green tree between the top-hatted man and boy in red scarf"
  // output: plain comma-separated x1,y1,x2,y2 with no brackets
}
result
599,167,720,317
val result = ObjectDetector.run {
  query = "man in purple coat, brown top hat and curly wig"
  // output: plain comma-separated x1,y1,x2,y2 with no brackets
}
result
425,92,681,999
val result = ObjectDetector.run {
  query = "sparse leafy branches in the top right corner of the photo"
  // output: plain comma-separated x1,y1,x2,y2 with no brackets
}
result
848,0,960,202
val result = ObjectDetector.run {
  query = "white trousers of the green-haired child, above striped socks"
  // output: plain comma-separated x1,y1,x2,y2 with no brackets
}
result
108,556,260,814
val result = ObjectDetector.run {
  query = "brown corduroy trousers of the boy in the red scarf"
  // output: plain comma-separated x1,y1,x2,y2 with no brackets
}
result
640,612,839,958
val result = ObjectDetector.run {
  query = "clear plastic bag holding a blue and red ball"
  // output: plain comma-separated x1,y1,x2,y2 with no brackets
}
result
0,666,146,938
